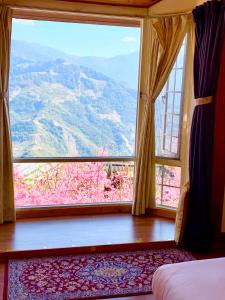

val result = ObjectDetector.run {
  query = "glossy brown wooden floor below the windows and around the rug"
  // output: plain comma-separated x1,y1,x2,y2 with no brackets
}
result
0,214,174,300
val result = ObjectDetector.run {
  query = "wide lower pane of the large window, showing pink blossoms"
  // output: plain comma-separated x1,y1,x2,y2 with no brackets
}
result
14,162,134,206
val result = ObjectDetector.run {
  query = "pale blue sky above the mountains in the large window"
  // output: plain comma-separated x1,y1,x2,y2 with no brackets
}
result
12,19,140,57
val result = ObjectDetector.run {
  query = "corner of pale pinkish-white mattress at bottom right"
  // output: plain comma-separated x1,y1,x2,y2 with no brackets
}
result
152,257,225,300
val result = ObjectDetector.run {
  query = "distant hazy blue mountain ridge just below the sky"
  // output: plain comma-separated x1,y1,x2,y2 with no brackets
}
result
11,40,139,90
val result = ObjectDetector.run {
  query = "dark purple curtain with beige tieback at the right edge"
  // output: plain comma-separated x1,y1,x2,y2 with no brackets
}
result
184,0,225,250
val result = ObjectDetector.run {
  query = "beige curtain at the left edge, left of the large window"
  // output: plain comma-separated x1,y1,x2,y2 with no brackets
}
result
0,6,15,224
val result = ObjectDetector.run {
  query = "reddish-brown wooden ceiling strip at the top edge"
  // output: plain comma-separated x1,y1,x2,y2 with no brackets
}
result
59,0,161,8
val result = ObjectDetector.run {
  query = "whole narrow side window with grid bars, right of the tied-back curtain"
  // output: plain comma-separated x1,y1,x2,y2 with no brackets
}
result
155,38,187,208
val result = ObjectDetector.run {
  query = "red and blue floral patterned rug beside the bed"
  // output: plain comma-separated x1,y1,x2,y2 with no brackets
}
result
4,248,193,300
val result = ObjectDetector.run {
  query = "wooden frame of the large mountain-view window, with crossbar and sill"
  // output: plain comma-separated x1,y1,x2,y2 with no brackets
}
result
12,7,143,213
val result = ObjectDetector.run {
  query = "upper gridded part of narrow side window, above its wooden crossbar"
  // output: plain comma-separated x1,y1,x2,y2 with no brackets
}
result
155,39,186,158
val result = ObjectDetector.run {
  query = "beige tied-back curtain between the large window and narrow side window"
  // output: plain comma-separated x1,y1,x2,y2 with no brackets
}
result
132,15,192,215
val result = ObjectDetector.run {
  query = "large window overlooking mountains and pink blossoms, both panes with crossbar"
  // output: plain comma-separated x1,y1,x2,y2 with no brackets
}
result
9,19,140,207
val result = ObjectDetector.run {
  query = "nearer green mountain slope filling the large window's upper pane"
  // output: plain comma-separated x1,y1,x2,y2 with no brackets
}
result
10,57,137,157
